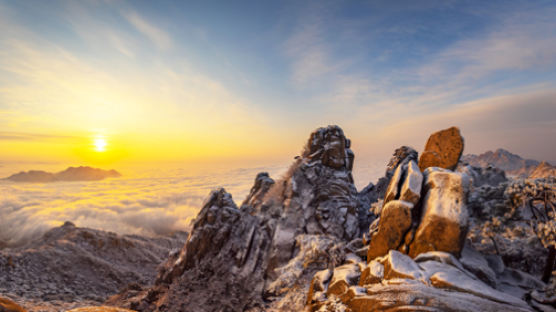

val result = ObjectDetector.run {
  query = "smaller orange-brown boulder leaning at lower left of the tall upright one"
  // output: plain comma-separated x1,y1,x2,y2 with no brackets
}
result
367,200,413,261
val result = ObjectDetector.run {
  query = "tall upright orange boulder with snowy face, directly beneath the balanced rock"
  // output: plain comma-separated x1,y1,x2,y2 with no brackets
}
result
409,168,468,258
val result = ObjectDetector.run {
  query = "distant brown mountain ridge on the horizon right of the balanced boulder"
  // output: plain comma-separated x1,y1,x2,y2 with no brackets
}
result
461,148,540,177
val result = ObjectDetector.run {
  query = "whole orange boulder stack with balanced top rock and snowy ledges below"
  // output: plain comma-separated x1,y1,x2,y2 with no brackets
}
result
307,128,556,312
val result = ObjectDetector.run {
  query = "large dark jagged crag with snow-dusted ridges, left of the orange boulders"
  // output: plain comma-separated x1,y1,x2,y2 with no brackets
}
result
109,126,370,311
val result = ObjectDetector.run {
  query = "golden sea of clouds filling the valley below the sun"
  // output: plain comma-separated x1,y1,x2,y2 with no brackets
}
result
0,161,383,246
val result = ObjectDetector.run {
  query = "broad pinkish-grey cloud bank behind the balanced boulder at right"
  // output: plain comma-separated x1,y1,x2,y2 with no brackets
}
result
348,86,556,161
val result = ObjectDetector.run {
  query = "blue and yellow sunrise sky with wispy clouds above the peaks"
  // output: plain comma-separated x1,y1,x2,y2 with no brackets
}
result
0,0,556,170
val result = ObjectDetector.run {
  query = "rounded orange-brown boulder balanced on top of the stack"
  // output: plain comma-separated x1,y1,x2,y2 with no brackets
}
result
419,127,463,171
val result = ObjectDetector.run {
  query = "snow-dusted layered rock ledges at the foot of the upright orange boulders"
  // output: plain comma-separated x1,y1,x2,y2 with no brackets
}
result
307,247,550,312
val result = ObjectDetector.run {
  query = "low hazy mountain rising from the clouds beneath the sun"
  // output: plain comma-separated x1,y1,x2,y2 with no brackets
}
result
6,166,121,183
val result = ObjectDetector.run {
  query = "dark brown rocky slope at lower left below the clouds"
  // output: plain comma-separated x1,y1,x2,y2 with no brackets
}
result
0,222,187,311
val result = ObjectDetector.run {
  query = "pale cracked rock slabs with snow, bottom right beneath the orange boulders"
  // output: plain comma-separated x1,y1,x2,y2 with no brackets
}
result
308,251,540,312
